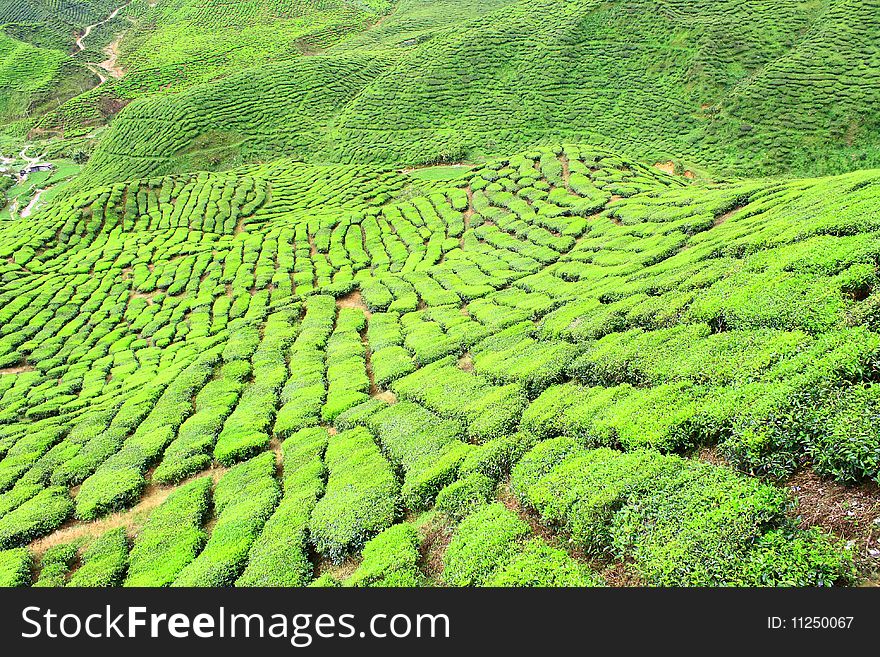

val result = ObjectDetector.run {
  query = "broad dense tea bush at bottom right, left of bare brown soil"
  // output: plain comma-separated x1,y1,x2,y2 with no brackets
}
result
511,438,852,586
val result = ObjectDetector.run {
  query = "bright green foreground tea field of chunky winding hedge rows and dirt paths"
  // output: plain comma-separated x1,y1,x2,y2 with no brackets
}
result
0,145,880,586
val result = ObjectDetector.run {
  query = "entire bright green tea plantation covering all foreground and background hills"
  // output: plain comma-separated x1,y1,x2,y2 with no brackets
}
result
0,0,880,587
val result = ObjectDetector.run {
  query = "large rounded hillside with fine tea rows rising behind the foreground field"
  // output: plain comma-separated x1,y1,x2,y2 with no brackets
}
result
67,0,880,182
